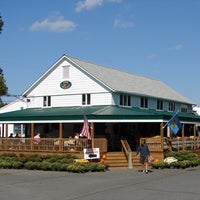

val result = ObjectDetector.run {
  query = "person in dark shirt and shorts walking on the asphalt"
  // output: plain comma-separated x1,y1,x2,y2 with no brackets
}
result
136,140,150,174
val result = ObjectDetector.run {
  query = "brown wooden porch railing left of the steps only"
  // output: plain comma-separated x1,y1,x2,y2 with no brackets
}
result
0,138,107,152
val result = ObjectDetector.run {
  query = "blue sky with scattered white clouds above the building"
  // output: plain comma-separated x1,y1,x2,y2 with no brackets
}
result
0,0,200,106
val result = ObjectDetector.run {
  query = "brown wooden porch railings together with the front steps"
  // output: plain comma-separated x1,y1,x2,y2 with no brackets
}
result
0,136,200,168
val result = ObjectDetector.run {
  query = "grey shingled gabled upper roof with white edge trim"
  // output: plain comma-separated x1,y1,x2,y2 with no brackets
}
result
23,55,194,104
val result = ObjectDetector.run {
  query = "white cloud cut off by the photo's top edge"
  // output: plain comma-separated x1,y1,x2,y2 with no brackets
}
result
76,0,103,12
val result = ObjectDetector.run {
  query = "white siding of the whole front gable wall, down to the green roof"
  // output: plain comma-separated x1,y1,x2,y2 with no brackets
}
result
24,61,112,108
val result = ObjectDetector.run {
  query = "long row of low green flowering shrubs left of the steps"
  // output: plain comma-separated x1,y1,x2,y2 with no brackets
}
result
0,154,108,173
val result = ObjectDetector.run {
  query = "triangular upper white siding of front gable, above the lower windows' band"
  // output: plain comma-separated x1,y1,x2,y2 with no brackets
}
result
29,61,107,96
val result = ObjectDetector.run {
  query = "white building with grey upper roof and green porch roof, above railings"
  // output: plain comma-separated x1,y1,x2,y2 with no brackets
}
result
0,55,200,154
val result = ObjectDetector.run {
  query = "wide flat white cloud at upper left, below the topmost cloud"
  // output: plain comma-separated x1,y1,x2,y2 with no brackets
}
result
30,15,77,32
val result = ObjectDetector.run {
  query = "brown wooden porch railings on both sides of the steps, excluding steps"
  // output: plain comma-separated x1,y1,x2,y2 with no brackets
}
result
0,136,200,153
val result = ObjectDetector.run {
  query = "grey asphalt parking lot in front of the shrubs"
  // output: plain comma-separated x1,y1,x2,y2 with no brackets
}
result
0,167,200,200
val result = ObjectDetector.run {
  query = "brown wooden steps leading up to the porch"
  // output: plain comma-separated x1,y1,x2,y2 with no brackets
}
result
105,152,141,168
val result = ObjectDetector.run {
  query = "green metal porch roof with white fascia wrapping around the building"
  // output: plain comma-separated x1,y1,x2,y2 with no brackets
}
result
0,106,200,123
